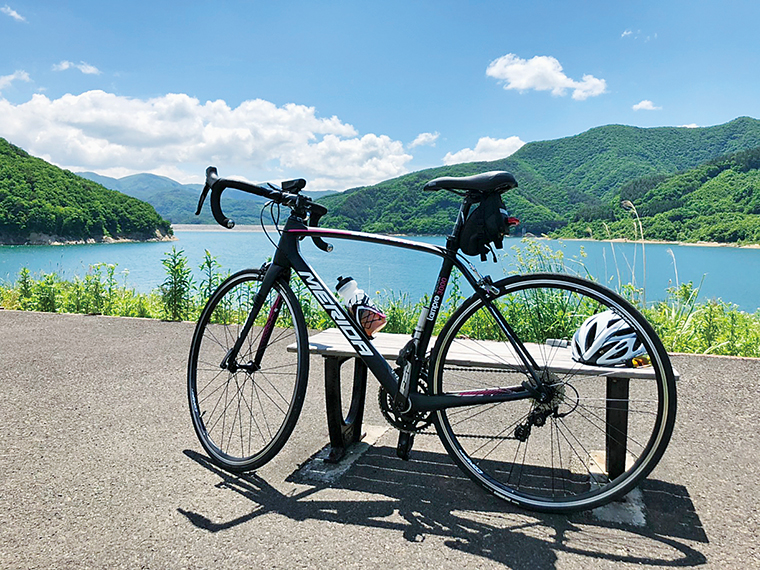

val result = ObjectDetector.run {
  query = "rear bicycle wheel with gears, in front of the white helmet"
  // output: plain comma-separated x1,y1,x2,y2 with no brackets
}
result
431,274,676,512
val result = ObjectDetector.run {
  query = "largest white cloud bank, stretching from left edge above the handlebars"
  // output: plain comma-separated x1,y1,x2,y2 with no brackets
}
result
0,91,412,190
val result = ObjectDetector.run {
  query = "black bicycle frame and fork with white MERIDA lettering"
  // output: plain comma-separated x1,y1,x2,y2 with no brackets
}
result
222,209,542,412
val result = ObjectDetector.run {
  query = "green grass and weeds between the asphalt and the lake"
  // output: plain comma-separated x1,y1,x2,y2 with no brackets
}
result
0,241,760,357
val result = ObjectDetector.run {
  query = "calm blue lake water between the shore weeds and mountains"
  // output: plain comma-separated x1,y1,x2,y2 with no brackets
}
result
0,229,760,312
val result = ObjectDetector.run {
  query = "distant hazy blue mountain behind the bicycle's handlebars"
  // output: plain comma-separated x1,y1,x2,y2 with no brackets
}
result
79,172,333,224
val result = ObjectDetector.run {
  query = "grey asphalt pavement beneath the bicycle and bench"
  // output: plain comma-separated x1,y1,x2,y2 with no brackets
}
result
0,311,760,570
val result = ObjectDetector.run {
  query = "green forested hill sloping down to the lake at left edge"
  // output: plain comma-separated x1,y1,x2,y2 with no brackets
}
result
0,138,171,244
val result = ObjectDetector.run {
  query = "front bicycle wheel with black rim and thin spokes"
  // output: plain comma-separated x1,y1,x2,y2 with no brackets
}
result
187,270,309,471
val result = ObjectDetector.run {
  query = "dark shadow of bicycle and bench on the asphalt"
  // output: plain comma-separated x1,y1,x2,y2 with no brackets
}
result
178,446,708,568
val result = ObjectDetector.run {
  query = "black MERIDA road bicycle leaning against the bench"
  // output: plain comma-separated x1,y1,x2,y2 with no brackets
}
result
188,167,676,512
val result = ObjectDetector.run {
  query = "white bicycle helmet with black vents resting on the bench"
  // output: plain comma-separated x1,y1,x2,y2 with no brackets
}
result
571,310,646,366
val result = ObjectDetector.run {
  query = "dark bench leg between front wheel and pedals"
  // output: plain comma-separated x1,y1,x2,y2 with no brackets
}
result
325,356,367,463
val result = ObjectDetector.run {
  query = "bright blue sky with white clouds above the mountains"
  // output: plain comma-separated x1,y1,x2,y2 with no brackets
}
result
0,0,760,190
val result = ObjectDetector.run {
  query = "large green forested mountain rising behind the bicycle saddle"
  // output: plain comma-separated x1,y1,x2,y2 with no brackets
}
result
322,117,760,239
